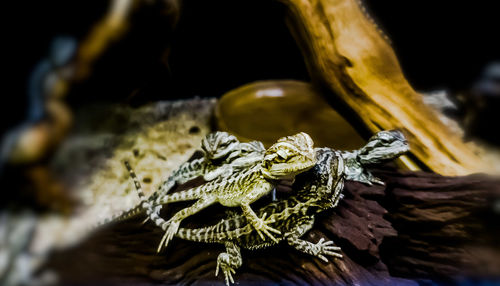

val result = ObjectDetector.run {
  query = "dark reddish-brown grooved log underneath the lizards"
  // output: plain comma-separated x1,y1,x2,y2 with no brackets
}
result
46,171,500,285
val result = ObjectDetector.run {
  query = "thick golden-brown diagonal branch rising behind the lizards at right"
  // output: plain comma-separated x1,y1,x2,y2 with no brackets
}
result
282,0,486,175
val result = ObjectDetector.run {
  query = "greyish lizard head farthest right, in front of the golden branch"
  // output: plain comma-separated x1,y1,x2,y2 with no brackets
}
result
358,130,410,165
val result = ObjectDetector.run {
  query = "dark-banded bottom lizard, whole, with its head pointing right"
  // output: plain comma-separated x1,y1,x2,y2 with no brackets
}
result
123,131,408,285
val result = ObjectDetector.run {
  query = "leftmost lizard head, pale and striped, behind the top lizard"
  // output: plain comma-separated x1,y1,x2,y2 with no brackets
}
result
201,131,239,160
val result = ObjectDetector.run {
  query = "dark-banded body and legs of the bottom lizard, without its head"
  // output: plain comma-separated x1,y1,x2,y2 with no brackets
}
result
177,148,344,285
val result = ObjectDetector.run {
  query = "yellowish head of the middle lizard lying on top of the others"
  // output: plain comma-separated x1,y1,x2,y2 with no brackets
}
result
262,132,316,180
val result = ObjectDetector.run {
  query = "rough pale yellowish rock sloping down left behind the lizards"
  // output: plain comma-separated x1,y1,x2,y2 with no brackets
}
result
0,98,216,285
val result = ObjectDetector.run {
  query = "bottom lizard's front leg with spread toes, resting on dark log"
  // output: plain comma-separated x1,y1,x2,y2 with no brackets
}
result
285,217,342,262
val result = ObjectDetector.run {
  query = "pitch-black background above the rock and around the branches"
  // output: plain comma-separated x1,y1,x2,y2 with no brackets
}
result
0,0,500,133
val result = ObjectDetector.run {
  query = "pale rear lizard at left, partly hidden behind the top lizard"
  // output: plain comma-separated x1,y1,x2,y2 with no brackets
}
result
97,131,266,226
